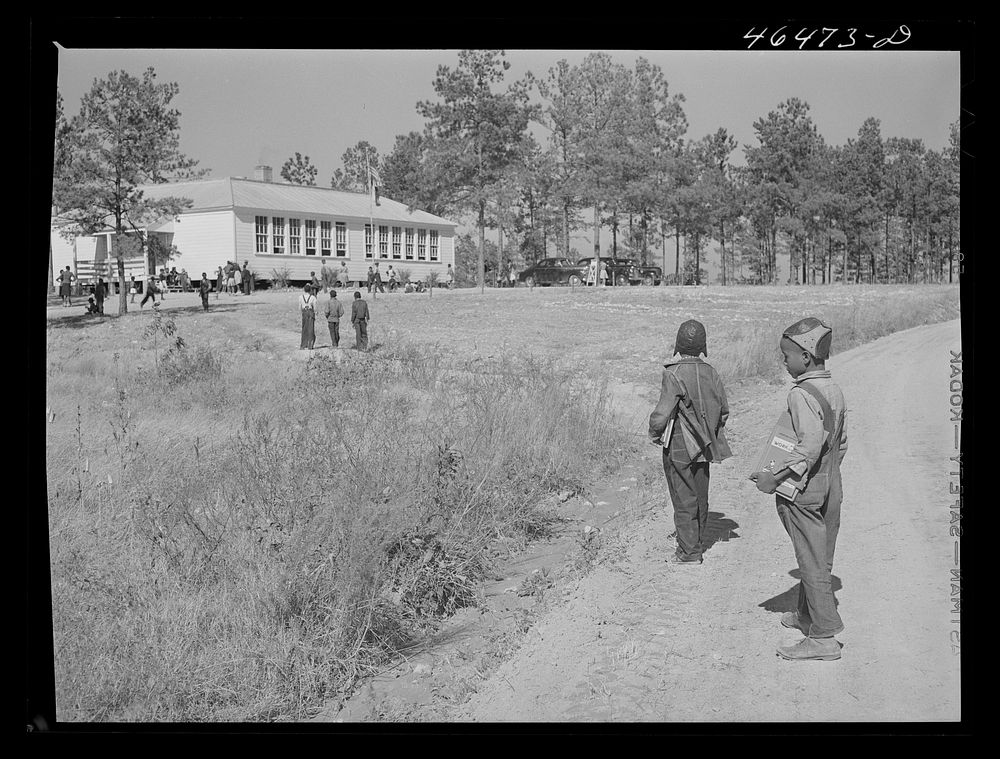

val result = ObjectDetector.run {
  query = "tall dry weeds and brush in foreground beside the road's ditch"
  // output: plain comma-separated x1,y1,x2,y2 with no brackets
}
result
50,336,626,721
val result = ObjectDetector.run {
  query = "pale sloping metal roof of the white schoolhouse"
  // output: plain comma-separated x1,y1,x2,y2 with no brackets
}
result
142,177,458,227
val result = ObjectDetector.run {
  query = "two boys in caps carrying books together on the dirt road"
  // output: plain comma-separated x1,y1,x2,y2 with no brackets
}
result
649,317,847,661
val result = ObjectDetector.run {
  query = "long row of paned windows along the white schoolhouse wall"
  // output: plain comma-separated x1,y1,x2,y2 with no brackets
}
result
254,216,440,261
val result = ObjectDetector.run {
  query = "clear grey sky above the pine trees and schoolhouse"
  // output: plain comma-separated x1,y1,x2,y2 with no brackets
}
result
52,48,961,186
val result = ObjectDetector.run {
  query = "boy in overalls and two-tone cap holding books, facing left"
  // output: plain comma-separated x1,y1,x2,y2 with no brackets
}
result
754,317,847,661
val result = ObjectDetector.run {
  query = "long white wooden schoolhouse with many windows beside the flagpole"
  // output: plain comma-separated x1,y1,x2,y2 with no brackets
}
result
51,166,458,290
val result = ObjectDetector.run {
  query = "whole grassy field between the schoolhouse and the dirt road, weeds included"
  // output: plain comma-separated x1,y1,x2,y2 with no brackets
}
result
46,286,959,721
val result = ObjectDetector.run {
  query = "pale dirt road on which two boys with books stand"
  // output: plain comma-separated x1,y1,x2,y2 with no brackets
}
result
447,321,961,722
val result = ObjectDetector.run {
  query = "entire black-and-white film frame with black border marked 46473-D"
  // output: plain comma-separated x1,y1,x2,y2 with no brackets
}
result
26,17,976,735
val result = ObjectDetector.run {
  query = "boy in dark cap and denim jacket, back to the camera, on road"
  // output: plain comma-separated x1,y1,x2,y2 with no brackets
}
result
649,319,732,565
